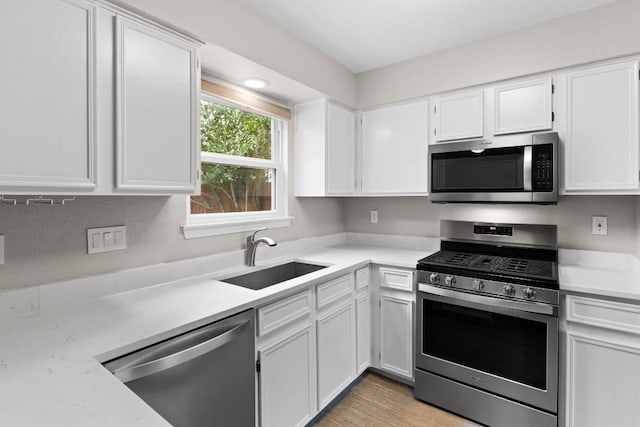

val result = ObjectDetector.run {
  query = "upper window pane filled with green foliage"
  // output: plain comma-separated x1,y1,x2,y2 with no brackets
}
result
200,100,272,159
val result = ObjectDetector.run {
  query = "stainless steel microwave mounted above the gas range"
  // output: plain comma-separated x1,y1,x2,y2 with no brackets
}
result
429,132,558,204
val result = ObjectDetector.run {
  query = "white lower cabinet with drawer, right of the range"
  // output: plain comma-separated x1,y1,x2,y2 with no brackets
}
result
564,296,640,427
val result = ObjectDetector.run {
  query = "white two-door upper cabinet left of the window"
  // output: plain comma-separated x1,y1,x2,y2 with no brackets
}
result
0,0,200,195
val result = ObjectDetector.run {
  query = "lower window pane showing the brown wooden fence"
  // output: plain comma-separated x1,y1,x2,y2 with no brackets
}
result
191,163,275,215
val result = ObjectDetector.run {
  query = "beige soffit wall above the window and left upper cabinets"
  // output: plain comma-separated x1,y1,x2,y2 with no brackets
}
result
120,0,357,106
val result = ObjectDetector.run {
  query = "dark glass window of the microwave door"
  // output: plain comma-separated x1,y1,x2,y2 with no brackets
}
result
431,147,524,193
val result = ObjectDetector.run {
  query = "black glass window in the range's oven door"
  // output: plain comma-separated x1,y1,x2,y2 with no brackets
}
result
422,299,547,390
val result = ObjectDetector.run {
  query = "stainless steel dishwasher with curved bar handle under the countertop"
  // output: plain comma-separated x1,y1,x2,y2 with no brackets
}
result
104,310,256,427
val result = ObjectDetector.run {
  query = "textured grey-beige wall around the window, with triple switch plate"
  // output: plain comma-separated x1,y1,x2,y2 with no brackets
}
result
0,122,344,291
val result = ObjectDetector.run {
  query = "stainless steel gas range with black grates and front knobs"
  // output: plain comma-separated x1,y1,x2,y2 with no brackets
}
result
414,221,559,427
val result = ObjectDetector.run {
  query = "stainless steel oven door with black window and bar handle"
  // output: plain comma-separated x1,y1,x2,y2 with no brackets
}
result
416,284,558,413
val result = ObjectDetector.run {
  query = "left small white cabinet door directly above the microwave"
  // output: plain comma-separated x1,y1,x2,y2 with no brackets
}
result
433,89,484,141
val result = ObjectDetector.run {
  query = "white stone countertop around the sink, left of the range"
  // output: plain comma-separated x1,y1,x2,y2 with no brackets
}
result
0,245,430,426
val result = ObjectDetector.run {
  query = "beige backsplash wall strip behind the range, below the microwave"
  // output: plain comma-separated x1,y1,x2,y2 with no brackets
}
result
345,196,640,253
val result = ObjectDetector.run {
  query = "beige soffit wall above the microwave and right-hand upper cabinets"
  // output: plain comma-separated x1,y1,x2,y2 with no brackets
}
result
358,0,640,108
